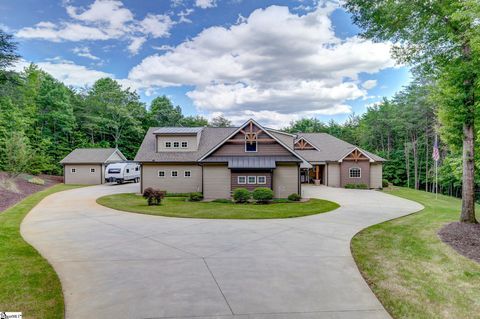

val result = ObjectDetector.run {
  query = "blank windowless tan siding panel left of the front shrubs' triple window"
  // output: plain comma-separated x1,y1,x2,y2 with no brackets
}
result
203,165,230,199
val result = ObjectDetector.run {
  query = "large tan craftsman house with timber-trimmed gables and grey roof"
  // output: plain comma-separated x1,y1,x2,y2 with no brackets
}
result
135,119,384,199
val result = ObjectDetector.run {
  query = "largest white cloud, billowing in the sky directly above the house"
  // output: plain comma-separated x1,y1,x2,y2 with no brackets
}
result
129,4,395,124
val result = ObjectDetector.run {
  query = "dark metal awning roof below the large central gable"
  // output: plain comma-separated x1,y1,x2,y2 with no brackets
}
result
202,156,300,169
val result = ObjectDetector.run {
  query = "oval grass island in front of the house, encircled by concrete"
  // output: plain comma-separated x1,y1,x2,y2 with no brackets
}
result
97,194,339,219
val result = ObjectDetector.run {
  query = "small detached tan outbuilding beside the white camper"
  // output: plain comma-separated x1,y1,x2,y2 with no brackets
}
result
60,148,127,185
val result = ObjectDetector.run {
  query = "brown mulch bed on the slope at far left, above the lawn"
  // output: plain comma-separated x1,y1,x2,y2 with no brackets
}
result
0,172,63,213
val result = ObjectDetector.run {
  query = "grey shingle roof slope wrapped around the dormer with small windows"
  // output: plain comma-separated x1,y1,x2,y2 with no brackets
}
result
135,127,237,162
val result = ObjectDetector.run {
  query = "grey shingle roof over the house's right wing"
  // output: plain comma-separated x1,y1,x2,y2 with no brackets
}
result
295,133,385,162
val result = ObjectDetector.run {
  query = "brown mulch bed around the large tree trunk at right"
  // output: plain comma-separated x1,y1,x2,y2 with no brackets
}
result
438,222,480,263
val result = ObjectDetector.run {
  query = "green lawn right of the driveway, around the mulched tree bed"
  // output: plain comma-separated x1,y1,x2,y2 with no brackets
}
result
352,188,480,319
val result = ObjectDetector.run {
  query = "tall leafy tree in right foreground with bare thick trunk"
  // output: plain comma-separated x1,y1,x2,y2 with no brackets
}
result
345,0,480,223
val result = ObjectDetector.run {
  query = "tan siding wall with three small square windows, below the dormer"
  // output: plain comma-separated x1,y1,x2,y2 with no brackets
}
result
142,164,202,193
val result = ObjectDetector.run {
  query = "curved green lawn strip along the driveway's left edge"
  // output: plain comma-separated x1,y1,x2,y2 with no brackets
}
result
0,184,83,318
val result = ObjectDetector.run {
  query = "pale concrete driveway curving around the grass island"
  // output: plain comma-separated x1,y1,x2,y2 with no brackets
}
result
21,184,422,319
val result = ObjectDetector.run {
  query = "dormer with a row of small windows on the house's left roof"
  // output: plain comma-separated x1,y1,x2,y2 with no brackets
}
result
153,127,203,152
